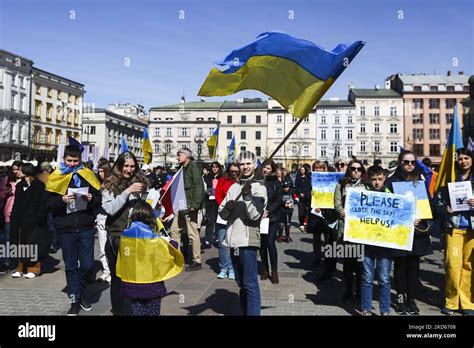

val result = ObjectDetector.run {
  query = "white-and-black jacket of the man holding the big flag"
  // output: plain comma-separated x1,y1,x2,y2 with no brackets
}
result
219,176,268,248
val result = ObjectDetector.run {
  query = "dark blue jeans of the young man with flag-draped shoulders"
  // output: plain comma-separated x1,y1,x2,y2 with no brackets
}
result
58,229,95,303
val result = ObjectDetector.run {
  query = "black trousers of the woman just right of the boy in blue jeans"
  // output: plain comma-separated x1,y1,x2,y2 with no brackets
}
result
393,255,420,300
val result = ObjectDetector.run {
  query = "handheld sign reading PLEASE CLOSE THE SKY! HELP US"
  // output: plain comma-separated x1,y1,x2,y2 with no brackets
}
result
344,188,416,251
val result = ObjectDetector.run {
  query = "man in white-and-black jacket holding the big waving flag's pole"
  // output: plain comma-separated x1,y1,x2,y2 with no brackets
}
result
219,151,267,315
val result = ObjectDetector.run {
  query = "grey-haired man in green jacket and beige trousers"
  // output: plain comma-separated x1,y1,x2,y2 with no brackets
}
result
170,147,204,271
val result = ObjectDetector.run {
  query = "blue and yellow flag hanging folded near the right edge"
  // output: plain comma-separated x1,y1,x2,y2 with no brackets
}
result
435,106,464,192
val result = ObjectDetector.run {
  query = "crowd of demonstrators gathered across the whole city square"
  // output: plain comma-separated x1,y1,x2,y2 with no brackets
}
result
0,145,474,316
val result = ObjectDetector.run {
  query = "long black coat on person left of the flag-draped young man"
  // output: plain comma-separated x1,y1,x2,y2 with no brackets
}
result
10,179,52,262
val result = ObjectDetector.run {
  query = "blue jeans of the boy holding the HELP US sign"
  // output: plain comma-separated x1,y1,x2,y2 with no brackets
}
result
361,245,392,314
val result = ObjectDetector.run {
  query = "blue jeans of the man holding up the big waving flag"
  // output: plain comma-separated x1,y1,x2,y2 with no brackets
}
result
230,247,261,315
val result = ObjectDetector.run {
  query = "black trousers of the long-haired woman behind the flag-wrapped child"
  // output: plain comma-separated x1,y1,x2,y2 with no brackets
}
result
105,237,131,315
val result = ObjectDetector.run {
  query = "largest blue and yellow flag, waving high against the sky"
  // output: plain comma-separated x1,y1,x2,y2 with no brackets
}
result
198,32,365,118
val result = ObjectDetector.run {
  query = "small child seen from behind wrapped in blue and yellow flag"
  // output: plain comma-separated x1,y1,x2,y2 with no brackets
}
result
117,201,184,316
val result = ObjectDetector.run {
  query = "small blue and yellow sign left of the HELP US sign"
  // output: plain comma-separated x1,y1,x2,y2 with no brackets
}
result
311,172,344,209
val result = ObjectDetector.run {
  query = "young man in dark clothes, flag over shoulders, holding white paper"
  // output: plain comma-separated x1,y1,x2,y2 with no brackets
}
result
46,145,102,316
